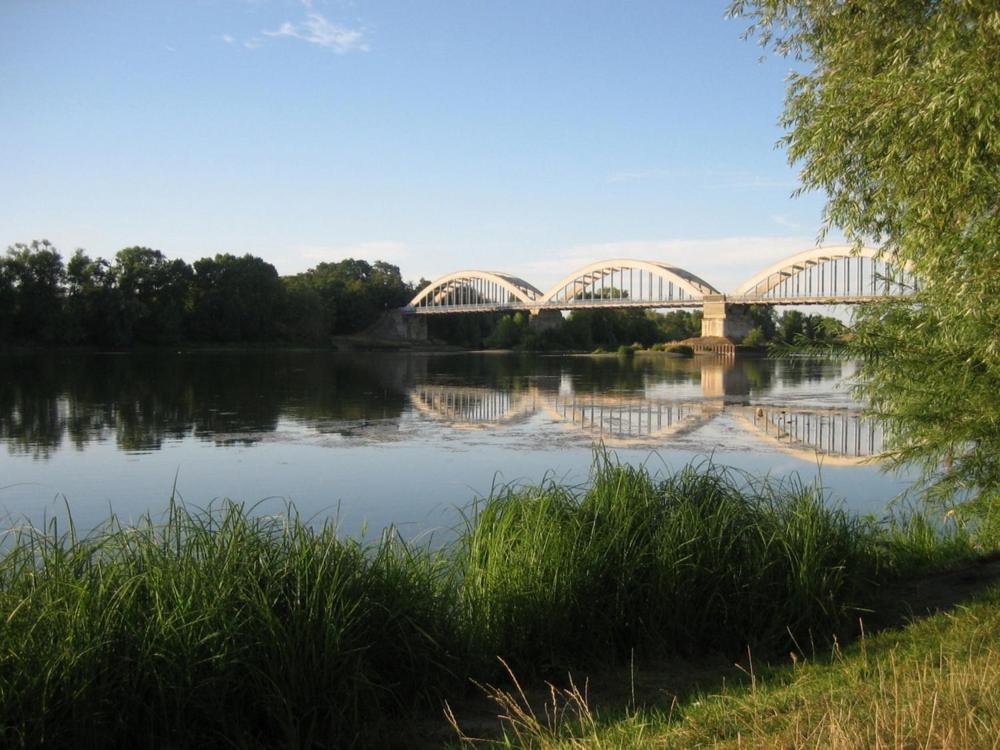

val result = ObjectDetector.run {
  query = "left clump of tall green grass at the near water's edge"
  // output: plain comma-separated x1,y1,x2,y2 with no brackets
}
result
0,503,455,747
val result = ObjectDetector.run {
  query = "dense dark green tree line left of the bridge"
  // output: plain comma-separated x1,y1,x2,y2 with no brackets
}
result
0,240,418,347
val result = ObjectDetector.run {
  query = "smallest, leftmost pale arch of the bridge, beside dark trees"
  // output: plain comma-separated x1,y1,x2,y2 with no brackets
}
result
410,271,542,312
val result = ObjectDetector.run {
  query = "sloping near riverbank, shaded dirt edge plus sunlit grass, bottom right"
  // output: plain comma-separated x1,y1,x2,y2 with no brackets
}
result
455,556,1000,750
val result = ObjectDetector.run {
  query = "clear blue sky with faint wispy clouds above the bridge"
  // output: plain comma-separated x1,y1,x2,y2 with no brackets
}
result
0,0,836,291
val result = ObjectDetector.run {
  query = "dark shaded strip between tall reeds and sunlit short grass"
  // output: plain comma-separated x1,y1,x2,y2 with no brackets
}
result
424,551,1000,748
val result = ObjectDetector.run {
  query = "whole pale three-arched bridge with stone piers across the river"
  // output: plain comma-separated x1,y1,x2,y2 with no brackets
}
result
402,245,919,341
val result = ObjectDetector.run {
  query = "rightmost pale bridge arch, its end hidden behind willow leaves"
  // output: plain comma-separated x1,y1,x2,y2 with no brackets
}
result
729,245,916,302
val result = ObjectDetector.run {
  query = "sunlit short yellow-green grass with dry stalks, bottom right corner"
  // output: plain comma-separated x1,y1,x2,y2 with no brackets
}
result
456,585,1000,750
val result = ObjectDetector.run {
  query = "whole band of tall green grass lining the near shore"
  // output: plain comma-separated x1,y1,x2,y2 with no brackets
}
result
0,457,984,748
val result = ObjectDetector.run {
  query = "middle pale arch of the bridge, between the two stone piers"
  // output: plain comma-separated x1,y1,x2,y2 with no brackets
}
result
541,259,719,307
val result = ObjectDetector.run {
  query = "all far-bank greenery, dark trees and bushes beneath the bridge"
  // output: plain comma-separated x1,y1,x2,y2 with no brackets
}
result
0,240,845,358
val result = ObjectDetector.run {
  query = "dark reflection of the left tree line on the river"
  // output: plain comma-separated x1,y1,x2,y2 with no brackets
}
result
0,353,412,458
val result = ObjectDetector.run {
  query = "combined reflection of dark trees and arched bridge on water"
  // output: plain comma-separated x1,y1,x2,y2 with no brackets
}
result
0,352,884,463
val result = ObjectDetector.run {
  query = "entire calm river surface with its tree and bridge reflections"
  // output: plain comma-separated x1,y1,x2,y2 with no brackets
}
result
0,352,906,536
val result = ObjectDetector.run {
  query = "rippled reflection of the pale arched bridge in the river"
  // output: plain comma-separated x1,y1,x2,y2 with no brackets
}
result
410,360,885,465
